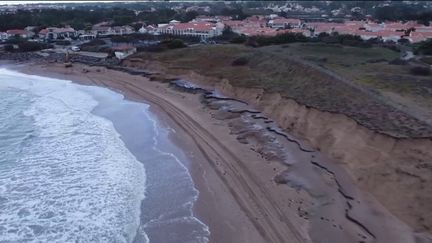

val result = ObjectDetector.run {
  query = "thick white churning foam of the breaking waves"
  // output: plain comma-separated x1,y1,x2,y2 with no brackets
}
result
0,69,145,242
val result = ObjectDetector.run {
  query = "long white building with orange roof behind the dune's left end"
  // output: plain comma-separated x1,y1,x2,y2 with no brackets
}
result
157,22,224,39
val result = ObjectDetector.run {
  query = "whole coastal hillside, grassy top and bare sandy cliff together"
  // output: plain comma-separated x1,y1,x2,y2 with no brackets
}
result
123,43,432,232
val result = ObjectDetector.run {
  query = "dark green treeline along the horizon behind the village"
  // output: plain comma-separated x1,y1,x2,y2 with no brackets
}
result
0,1,432,31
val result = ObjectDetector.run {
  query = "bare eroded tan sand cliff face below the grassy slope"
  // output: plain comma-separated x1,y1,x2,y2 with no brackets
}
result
216,80,432,232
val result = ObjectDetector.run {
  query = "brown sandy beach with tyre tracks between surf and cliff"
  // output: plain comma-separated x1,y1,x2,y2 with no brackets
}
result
7,61,428,242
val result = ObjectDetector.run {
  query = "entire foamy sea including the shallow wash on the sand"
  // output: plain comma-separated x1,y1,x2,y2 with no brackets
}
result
0,69,210,243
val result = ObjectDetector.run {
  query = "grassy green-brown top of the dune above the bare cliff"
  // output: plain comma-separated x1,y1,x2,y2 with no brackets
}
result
133,43,432,136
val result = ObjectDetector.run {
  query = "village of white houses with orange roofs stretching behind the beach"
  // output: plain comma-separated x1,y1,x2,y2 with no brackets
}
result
0,14,432,58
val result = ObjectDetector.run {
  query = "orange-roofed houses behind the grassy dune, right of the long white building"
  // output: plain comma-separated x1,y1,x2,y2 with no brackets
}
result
222,15,432,43
